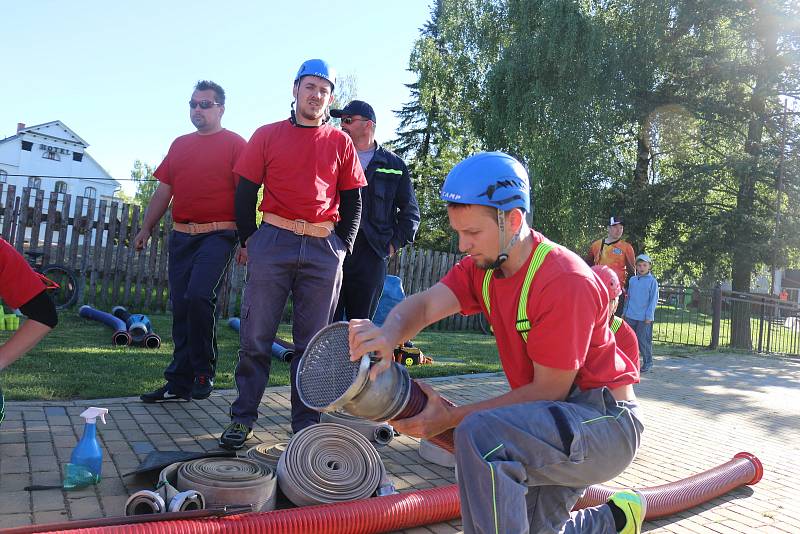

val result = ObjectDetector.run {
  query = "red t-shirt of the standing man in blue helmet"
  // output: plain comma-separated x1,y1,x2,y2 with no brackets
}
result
234,119,367,223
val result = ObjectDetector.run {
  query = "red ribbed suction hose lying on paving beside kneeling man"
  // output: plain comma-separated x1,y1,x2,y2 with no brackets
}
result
12,453,763,534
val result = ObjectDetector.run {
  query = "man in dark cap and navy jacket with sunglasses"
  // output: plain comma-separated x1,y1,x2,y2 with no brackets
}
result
331,100,419,321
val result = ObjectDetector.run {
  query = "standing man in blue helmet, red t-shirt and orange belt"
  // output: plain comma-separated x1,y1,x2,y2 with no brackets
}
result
219,59,367,449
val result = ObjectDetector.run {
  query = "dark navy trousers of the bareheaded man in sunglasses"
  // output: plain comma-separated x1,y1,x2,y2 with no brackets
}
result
164,230,236,394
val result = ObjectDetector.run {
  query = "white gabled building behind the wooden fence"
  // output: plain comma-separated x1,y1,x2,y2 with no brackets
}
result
0,121,121,205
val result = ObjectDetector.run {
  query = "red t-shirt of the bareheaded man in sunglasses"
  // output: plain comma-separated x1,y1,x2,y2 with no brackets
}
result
153,130,247,223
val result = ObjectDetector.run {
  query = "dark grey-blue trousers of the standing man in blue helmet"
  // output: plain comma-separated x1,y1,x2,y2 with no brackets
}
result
231,224,346,432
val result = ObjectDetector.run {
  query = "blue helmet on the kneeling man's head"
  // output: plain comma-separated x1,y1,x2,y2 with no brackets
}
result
440,152,531,213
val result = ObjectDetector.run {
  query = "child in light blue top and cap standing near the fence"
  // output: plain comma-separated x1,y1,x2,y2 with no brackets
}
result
623,254,658,373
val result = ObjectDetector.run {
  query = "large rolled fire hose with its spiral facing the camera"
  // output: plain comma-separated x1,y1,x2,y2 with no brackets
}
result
278,423,386,506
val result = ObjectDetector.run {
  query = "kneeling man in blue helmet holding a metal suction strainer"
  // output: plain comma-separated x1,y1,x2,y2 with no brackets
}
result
350,152,646,534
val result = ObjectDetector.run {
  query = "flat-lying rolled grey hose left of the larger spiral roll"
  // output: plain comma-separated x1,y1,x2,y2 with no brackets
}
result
175,458,277,511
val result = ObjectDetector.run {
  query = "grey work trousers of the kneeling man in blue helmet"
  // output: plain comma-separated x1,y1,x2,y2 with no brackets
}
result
455,388,644,534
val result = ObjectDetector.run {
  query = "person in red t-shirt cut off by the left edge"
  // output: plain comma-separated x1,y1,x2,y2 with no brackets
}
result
0,238,58,423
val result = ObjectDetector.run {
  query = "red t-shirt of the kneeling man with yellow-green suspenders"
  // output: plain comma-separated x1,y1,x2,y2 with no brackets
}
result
442,232,639,390
